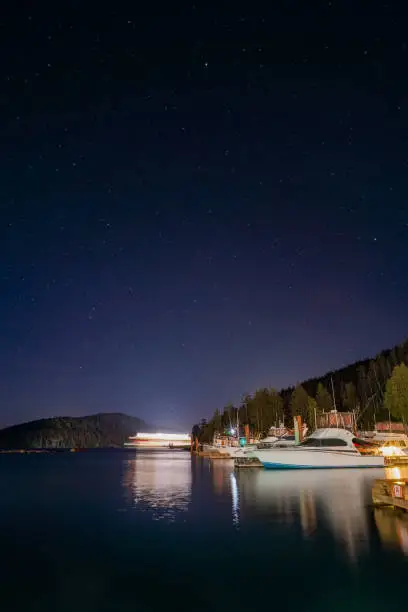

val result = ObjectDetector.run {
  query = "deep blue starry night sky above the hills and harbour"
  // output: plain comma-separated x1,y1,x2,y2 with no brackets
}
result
0,0,408,429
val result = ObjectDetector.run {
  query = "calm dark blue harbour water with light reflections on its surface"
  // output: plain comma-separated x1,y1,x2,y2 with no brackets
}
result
0,452,408,612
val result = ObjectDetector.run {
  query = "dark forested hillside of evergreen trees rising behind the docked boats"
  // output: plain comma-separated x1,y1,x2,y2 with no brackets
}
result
192,339,408,442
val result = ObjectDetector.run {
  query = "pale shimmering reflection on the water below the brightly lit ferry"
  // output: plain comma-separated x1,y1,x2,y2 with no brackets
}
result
123,451,192,521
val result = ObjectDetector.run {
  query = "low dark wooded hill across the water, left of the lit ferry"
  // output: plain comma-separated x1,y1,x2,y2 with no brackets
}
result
0,413,157,449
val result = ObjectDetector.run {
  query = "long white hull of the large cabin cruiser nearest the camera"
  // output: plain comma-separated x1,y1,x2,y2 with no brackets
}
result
254,448,384,470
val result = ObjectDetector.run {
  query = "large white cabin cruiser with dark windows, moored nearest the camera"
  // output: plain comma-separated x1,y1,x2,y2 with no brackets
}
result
254,428,384,469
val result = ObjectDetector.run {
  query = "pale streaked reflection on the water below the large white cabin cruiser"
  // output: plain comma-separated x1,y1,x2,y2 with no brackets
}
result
233,470,384,559
